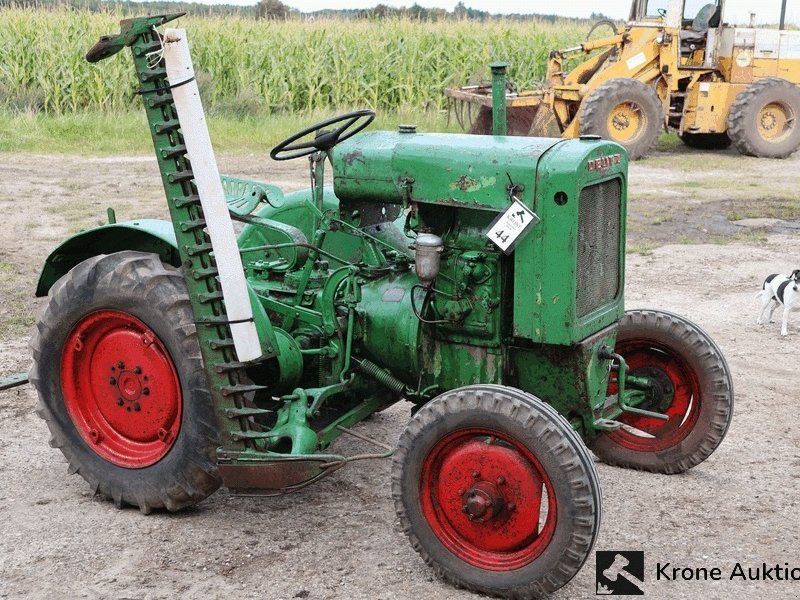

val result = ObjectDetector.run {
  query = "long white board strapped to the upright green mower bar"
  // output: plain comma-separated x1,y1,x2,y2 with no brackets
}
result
164,29,262,362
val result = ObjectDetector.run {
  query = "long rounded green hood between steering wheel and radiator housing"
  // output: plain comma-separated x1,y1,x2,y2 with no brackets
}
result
332,131,569,211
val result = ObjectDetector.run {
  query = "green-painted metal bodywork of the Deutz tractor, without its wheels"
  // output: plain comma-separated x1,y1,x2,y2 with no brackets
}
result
72,20,646,492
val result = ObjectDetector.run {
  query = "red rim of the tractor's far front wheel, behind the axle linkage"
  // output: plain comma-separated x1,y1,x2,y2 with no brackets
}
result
607,338,702,452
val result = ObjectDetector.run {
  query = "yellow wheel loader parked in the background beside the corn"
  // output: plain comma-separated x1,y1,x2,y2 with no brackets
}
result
445,0,800,159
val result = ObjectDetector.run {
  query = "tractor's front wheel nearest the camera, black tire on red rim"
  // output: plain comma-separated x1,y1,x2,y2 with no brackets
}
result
392,385,602,599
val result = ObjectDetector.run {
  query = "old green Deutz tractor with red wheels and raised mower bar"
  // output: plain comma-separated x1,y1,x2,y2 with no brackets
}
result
23,15,733,598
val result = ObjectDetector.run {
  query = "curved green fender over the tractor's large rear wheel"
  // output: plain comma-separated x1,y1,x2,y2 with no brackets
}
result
36,219,180,297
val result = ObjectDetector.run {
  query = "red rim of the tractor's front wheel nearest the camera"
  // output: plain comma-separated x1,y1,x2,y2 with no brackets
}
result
420,428,557,571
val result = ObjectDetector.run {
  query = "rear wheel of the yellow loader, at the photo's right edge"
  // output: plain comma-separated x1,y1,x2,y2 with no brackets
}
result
728,77,800,158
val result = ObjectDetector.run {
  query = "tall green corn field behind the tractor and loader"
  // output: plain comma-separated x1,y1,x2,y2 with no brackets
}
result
0,8,588,114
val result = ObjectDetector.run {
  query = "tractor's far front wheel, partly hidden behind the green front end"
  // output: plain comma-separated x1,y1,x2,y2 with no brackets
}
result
590,310,733,474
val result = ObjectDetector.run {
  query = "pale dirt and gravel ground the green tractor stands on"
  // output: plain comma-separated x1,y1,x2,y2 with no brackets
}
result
0,146,800,600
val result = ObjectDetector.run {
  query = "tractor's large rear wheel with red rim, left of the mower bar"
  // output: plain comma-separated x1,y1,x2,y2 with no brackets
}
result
31,251,220,514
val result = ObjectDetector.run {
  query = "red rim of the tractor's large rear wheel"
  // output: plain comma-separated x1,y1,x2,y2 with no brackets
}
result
61,310,182,468
